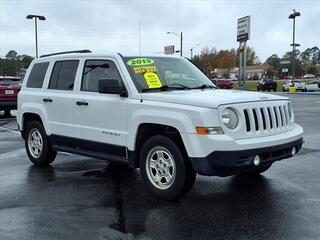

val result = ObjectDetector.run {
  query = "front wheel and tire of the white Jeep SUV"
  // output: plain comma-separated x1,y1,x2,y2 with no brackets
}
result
140,135,196,200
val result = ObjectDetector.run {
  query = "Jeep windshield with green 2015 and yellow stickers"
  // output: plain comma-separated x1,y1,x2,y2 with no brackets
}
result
124,57,215,91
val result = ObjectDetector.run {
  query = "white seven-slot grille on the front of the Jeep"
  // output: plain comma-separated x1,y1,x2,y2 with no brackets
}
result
243,103,292,132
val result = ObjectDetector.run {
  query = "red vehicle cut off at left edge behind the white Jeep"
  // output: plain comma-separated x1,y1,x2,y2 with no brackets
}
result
0,76,21,115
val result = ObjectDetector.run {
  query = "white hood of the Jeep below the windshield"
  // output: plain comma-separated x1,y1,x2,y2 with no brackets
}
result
142,89,288,108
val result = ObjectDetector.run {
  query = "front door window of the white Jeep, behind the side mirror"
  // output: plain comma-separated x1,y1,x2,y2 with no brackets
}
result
81,60,122,92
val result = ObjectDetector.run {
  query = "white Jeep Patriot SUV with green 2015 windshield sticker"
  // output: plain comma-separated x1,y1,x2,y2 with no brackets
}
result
17,50,303,200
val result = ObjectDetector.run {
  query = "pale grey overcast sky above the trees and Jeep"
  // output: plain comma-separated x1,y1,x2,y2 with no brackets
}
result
0,0,320,61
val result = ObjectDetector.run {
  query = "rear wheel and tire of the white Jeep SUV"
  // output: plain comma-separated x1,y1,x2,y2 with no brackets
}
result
25,121,57,167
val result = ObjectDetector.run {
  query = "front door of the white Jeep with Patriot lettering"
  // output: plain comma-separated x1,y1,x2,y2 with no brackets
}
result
75,58,128,158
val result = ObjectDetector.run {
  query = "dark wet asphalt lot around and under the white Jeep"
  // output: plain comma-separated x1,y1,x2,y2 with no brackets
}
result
0,95,320,240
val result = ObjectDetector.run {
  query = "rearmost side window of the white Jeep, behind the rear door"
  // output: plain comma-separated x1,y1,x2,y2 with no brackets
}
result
27,62,49,88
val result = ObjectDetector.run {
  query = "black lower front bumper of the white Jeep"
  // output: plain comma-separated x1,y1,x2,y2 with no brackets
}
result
190,138,302,176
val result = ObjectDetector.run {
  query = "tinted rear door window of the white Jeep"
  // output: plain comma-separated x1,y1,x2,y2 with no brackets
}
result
49,60,79,91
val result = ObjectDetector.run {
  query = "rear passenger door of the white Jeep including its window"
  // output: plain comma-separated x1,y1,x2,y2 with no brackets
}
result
42,60,80,139
